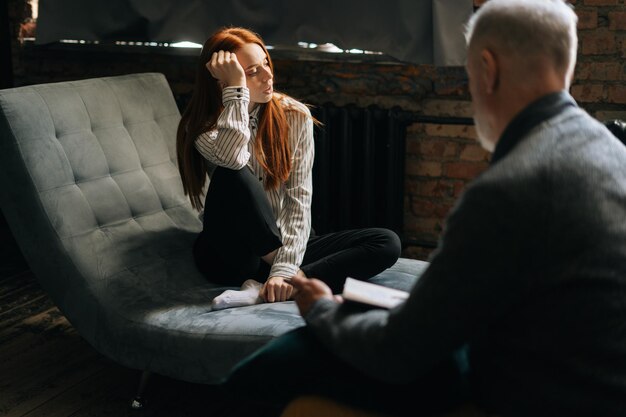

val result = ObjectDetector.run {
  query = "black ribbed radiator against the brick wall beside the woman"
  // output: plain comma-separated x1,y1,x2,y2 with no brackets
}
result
311,104,408,236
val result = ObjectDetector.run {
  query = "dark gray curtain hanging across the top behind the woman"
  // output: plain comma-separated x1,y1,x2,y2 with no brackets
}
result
37,0,473,65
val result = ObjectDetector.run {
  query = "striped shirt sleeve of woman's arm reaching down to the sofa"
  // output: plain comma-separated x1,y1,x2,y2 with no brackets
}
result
270,106,315,277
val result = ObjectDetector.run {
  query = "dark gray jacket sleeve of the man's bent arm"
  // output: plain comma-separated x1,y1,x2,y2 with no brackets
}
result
305,178,541,383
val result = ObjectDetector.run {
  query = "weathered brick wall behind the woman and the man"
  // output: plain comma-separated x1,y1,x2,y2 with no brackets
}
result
8,0,626,259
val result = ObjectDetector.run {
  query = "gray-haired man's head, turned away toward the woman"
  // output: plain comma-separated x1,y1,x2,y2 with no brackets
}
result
466,0,578,151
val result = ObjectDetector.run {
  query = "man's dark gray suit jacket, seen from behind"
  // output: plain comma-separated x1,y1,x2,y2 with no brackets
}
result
306,93,626,417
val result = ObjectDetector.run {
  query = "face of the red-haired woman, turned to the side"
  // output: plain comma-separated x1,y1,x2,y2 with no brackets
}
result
235,43,274,103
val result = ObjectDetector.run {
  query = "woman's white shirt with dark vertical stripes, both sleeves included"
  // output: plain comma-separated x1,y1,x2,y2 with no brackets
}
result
195,87,315,277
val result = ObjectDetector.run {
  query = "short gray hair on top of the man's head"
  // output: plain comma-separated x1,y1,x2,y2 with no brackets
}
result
465,0,578,72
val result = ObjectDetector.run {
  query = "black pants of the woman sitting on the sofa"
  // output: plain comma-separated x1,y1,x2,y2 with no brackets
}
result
194,168,400,292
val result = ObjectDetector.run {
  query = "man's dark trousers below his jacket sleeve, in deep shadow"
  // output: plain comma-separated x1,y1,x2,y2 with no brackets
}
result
219,326,470,417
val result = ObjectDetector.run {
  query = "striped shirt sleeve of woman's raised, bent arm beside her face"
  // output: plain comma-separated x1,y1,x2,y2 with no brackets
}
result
195,87,250,169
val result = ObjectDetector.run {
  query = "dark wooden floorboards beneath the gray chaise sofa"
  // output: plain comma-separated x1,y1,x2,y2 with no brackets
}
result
0,218,243,417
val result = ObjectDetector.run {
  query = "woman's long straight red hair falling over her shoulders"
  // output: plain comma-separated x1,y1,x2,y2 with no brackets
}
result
176,28,291,210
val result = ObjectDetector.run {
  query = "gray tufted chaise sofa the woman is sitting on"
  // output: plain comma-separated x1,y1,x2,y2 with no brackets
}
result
0,73,426,383
